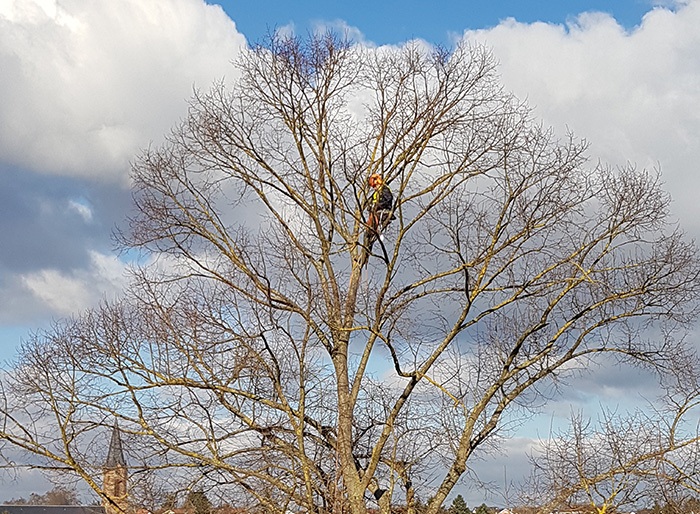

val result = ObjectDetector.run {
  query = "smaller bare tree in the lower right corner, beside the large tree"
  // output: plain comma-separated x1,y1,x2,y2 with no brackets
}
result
526,370,700,514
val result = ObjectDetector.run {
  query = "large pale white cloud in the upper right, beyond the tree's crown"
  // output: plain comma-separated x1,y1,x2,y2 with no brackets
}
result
463,0,700,236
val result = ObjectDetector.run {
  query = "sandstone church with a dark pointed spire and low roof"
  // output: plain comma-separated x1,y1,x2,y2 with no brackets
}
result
0,423,129,514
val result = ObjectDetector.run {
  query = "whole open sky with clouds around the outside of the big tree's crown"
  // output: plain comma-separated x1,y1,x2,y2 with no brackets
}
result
0,0,700,502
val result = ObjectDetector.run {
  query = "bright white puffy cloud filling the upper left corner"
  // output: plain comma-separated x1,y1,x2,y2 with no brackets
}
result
0,0,245,180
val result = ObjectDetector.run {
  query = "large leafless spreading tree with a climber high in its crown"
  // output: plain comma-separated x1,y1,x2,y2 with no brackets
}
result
0,34,699,514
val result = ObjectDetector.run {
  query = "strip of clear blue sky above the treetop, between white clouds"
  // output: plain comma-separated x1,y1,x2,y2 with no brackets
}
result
221,0,652,45
